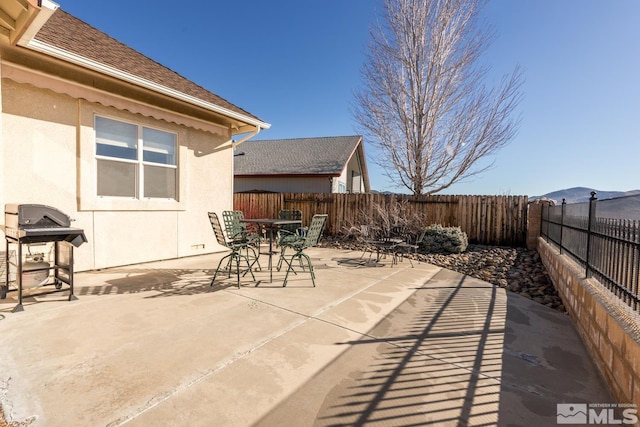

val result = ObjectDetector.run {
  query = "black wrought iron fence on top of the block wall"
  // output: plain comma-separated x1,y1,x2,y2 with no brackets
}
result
542,192,640,311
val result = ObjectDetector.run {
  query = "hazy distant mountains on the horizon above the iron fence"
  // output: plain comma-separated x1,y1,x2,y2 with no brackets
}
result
531,187,640,220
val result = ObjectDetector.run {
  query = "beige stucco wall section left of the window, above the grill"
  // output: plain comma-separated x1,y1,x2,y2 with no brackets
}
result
2,79,77,210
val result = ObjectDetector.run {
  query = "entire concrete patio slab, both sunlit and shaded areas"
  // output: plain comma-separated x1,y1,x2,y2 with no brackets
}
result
0,248,612,426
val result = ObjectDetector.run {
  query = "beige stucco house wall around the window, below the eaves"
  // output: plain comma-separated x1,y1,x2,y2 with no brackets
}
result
0,78,233,271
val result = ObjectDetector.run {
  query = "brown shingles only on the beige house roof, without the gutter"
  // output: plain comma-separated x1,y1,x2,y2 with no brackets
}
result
29,9,268,127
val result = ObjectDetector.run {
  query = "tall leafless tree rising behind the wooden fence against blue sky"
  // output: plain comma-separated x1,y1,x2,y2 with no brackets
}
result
354,0,522,195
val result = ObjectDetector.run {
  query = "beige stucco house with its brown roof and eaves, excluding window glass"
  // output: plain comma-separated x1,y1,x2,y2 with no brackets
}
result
0,0,270,271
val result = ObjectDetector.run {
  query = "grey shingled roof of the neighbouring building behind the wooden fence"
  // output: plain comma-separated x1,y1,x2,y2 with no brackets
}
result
234,135,362,176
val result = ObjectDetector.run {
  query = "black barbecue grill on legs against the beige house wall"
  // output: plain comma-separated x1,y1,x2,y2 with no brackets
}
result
0,203,87,311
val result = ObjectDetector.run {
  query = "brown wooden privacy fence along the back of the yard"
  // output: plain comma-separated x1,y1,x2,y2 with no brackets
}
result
233,193,528,246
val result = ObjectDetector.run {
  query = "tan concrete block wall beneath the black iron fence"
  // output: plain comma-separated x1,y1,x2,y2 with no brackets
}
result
538,238,640,407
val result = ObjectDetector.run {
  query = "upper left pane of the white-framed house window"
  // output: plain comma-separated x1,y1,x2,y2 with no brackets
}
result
96,117,138,160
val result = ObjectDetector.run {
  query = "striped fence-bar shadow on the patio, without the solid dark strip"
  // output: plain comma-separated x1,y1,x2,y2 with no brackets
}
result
255,276,505,426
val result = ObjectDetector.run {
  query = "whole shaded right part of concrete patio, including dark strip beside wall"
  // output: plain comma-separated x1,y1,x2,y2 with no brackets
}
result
258,270,612,426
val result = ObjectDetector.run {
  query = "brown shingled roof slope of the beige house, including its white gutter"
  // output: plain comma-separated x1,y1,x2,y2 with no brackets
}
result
11,4,270,133
